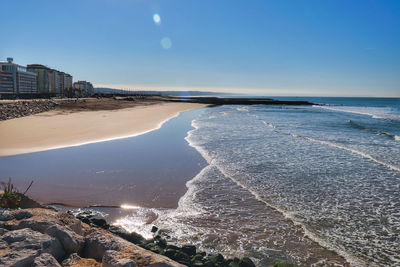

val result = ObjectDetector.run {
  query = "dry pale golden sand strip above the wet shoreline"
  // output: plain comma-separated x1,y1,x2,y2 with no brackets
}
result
0,102,204,157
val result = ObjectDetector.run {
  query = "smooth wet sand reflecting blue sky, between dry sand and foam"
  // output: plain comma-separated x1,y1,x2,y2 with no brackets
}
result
0,109,205,208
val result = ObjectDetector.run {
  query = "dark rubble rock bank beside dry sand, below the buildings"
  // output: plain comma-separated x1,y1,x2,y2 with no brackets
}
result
0,100,58,121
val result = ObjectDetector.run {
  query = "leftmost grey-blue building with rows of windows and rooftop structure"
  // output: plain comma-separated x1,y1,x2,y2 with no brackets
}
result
0,58,38,94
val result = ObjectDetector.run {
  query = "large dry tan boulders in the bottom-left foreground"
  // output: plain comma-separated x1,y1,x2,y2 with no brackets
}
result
0,208,184,267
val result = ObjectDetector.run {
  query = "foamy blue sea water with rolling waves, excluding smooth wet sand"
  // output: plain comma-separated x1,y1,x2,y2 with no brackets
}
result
155,98,400,266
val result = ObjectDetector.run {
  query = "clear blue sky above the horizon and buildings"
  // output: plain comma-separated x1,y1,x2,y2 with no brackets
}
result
0,0,400,97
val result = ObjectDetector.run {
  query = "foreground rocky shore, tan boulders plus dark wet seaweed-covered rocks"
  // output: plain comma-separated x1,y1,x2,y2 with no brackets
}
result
0,208,260,267
